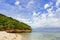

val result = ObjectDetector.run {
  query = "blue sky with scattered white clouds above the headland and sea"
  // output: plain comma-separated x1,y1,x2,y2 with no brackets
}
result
0,0,60,28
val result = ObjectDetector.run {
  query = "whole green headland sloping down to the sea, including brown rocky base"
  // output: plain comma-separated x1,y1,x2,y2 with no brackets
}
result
0,14,32,33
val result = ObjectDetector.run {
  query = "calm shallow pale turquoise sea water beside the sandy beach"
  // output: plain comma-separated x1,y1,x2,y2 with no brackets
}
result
20,32,60,40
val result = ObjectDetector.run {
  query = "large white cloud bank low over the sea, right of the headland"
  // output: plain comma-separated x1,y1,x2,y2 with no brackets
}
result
17,8,60,28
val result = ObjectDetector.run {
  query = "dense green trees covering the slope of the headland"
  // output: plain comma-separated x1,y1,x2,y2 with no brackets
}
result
0,14,32,30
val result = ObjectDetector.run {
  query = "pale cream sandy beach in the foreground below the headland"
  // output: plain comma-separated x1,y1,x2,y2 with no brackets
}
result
0,31,22,40
